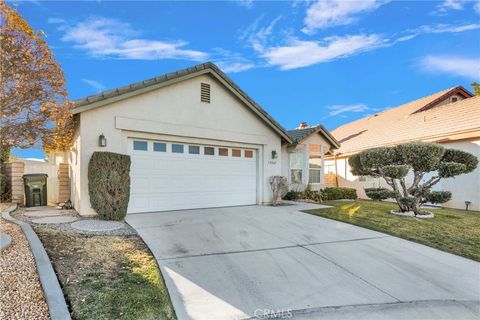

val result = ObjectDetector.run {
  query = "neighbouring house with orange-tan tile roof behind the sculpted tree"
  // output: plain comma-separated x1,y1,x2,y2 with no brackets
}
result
325,86,480,210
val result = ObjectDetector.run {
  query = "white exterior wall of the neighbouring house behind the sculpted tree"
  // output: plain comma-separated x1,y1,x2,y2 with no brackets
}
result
325,139,480,211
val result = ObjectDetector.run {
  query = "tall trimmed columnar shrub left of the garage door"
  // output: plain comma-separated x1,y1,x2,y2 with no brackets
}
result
88,152,131,220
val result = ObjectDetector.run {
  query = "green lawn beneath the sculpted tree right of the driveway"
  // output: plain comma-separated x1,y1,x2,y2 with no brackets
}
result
305,200,480,261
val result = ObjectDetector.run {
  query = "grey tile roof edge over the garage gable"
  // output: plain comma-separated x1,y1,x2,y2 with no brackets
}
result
73,62,291,142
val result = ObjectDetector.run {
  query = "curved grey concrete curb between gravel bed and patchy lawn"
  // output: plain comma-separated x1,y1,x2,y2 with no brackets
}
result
2,204,71,320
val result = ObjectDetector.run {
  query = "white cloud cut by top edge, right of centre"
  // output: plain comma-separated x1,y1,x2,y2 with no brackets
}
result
302,0,387,34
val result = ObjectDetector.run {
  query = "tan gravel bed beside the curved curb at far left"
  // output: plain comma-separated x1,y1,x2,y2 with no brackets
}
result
0,214,50,320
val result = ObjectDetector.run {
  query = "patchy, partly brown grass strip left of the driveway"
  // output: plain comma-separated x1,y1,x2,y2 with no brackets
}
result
36,228,175,320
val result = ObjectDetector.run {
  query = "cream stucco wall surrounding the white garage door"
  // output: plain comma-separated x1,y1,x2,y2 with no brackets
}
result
71,75,282,215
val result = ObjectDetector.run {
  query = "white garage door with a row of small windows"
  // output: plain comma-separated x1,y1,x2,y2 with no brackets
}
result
128,140,257,213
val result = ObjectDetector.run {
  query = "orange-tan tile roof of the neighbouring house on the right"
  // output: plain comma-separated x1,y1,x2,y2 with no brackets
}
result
332,87,480,154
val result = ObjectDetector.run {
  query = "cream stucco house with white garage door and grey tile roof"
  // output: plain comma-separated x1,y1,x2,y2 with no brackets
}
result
68,63,339,215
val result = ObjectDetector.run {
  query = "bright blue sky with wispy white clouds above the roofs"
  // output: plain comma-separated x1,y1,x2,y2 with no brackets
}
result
10,0,480,157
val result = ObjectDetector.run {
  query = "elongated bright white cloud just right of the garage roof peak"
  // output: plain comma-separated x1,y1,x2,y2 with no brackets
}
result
262,34,386,70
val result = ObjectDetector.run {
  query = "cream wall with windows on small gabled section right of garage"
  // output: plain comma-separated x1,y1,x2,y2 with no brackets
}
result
281,134,331,190
